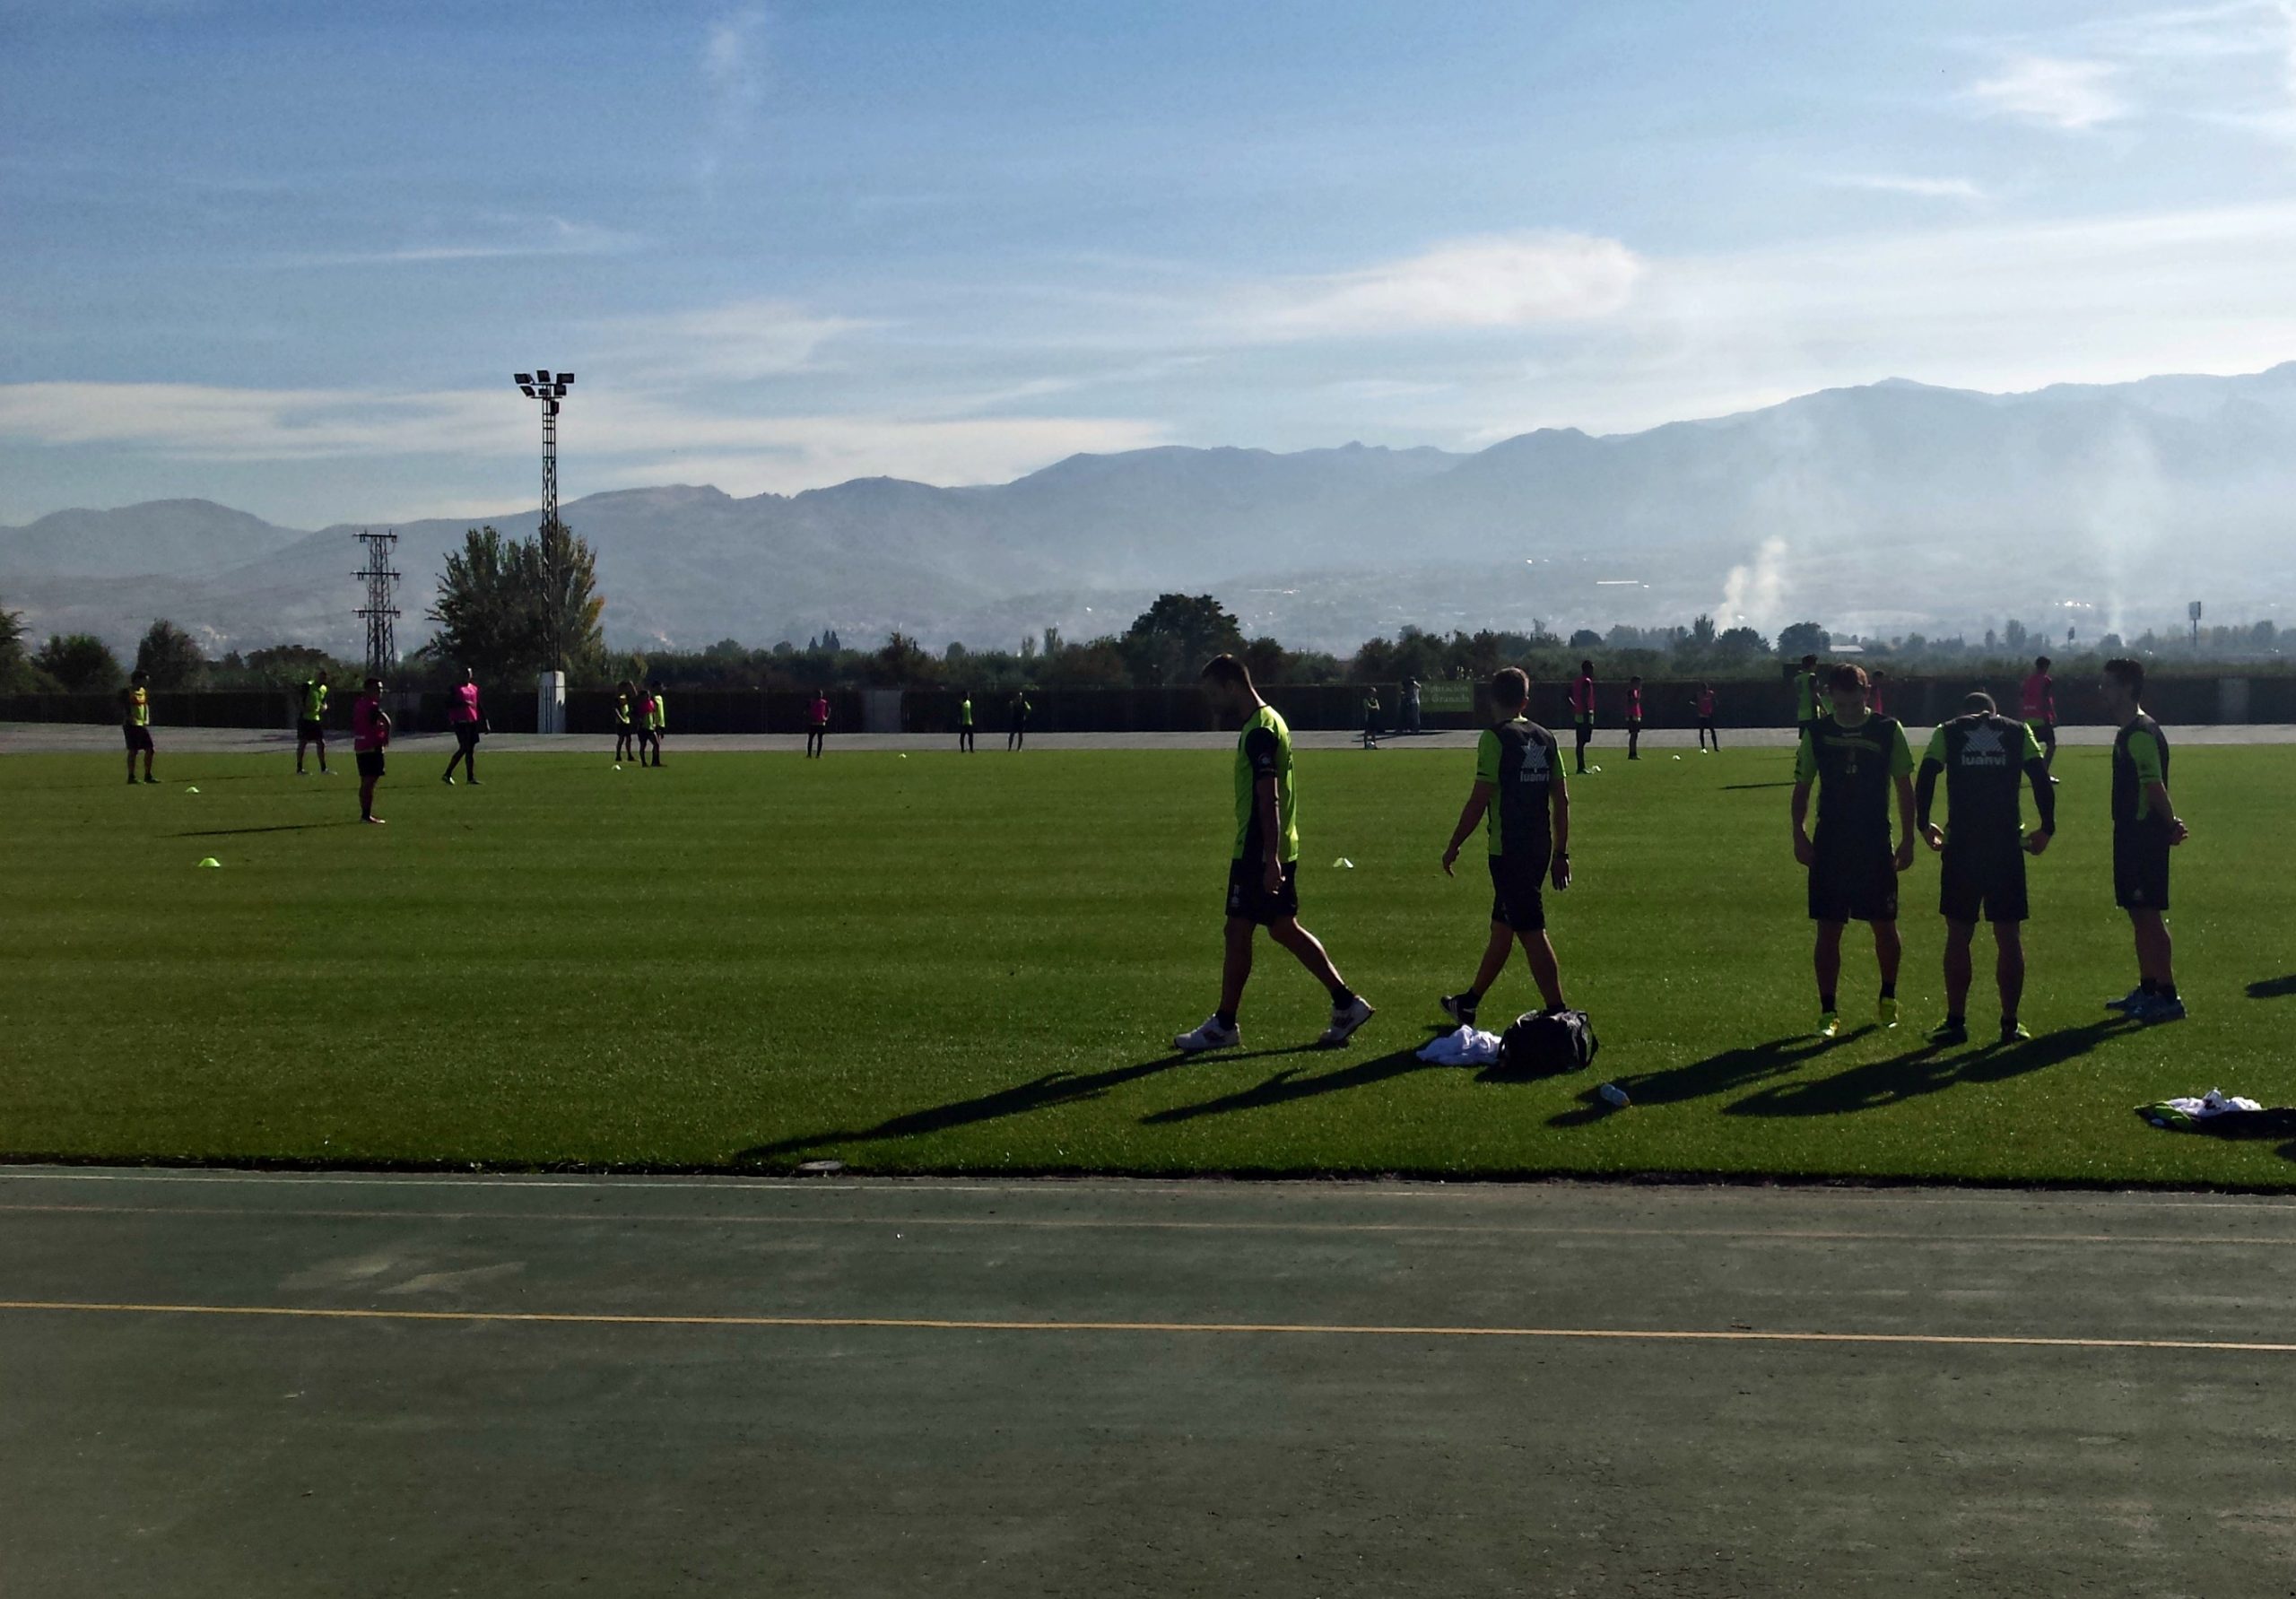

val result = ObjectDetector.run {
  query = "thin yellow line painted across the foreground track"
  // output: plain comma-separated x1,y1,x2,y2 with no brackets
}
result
0,1300,2296,1355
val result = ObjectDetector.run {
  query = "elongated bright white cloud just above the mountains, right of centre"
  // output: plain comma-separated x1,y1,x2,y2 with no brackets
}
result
1233,234,1641,338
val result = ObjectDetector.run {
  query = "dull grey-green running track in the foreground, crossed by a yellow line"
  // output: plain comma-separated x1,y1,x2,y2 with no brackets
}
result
0,1167,2296,1599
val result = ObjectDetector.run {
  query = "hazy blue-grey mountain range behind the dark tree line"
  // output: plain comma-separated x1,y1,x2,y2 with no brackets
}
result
0,363,2296,650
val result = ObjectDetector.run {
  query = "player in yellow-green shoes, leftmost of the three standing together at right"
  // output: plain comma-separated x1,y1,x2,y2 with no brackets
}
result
1793,666,1912,1038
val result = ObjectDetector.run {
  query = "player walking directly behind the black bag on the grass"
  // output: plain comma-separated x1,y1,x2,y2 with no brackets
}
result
1439,666,1570,1027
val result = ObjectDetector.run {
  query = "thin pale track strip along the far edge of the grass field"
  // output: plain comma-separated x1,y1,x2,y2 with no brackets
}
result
0,721,2296,758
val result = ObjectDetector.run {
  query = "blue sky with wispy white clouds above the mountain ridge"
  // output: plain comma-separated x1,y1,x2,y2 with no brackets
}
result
0,0,2296,526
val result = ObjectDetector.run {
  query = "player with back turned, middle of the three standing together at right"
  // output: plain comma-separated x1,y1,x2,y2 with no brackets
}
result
1912,694,2057,1043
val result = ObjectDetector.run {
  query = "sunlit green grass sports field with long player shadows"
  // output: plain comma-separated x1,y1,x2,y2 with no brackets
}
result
0,747,2296,1186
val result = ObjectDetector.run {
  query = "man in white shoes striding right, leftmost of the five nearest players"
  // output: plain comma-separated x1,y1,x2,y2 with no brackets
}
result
1171,655,1370,1055
